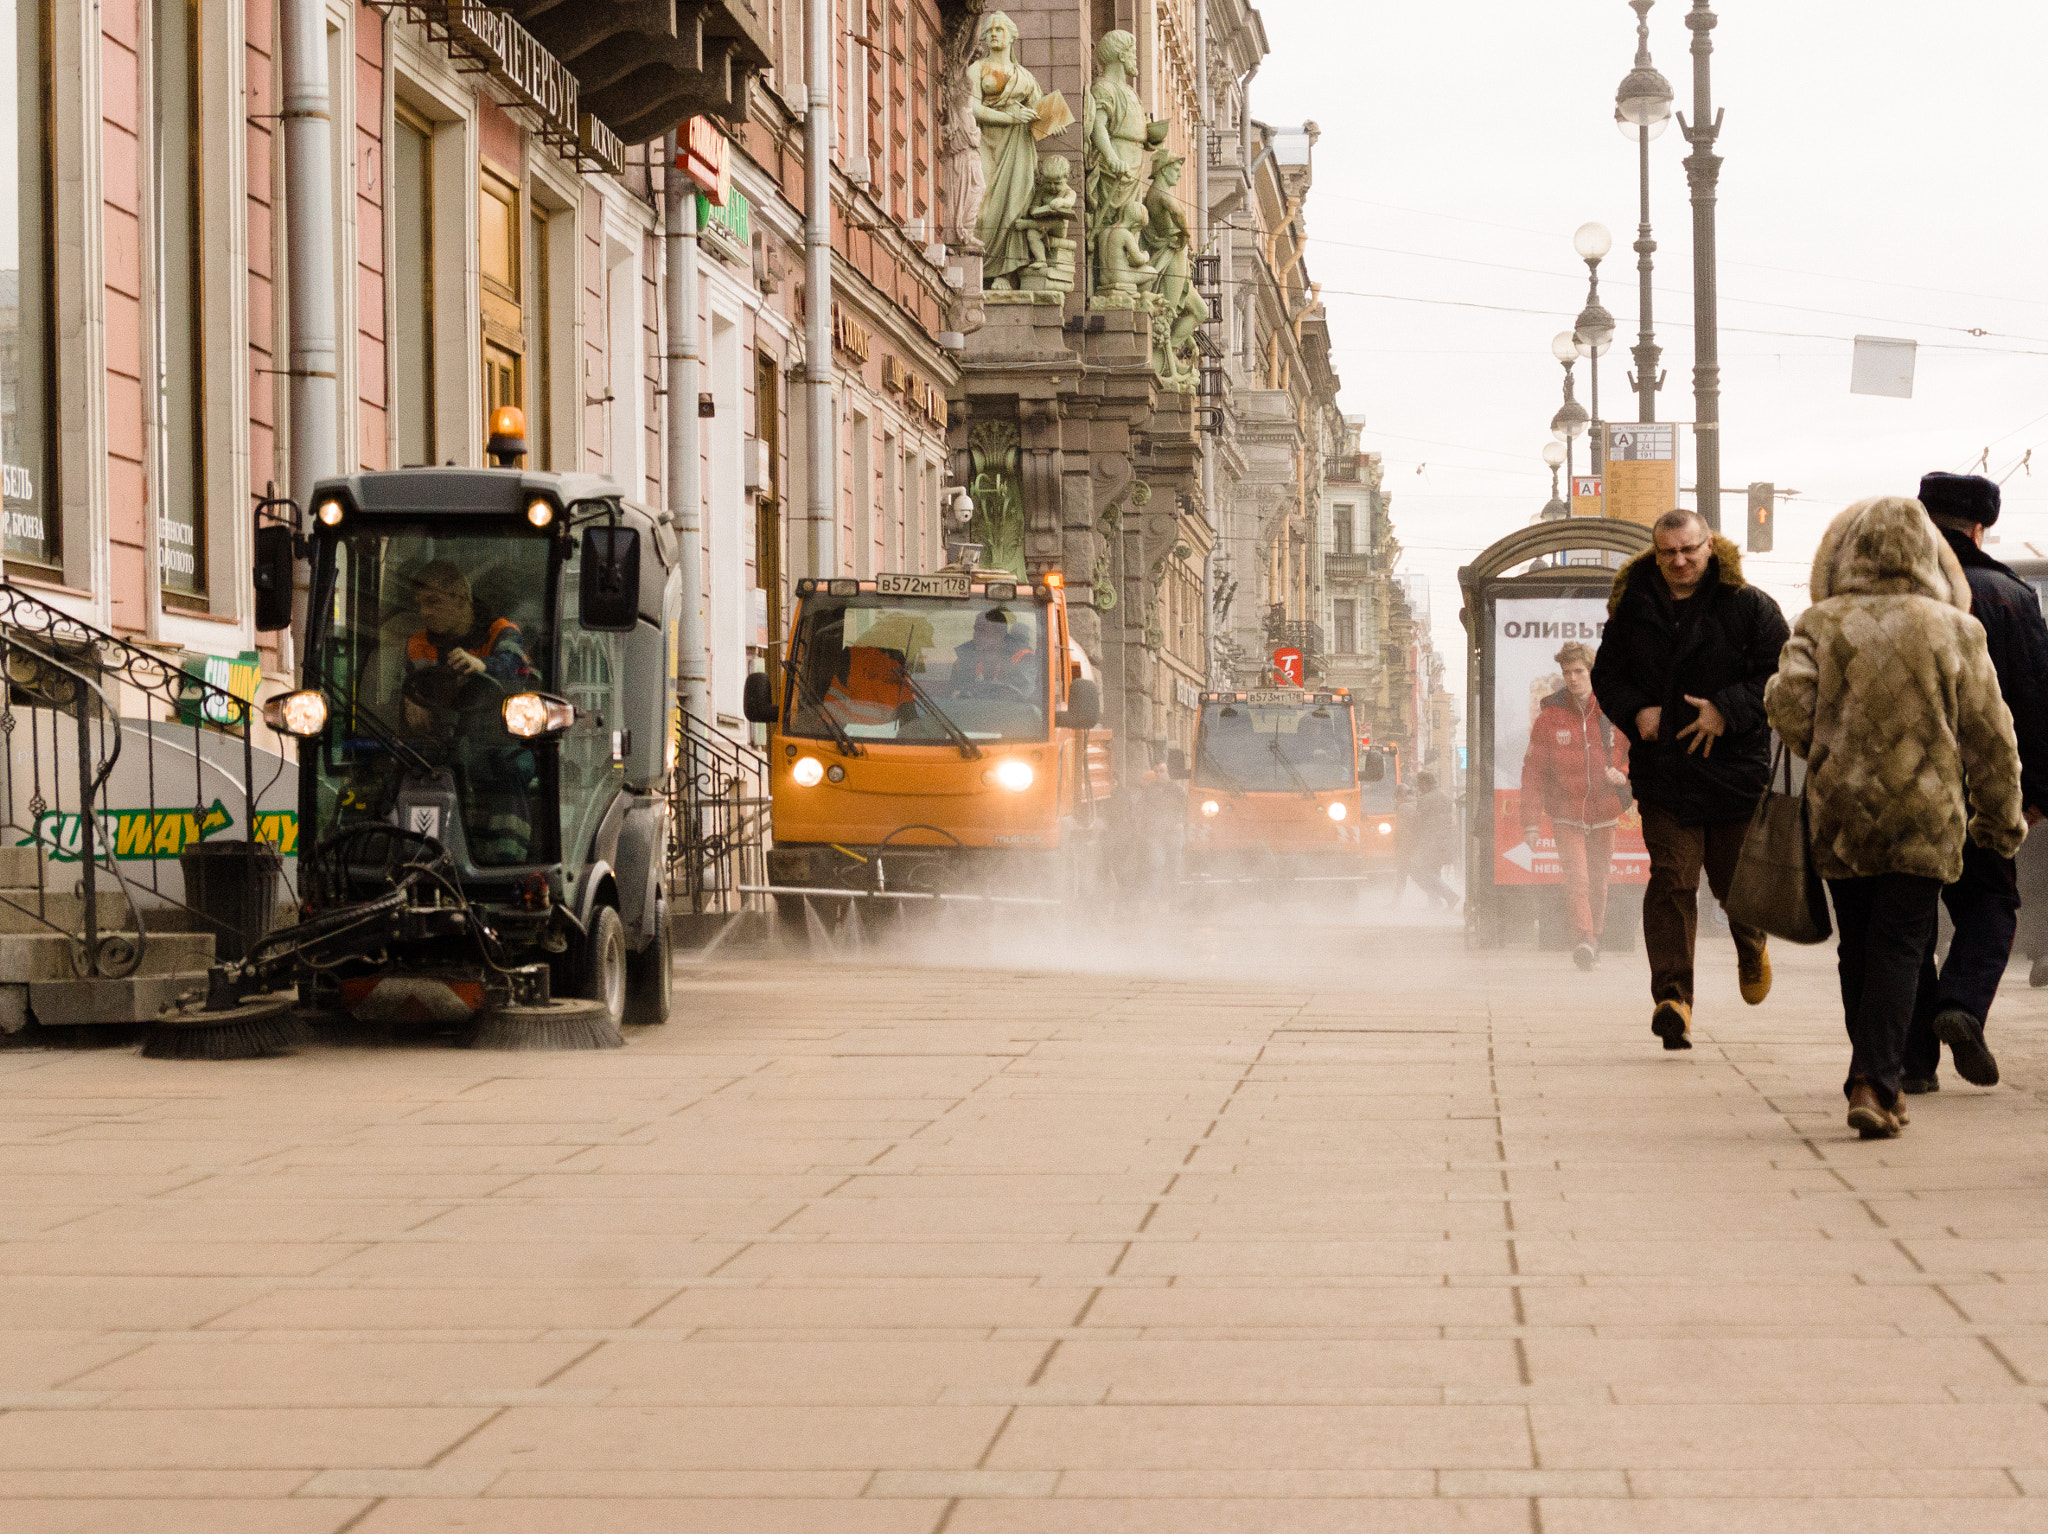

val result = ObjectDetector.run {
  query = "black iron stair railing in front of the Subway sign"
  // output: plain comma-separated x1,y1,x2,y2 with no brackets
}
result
0,580,297,979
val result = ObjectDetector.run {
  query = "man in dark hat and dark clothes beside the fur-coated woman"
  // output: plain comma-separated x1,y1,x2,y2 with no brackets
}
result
1901,473,2048,1092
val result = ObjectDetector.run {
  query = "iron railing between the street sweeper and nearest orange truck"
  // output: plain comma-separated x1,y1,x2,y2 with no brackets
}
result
668,709,772,915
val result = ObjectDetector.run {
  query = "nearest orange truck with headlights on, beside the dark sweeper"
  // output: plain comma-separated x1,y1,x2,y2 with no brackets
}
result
745,567,1106,913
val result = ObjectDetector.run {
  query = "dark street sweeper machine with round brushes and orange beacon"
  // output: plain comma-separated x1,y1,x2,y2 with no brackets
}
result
166,446,682,1049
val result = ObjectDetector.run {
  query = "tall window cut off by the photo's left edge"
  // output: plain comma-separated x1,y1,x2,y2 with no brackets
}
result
0,0,61,569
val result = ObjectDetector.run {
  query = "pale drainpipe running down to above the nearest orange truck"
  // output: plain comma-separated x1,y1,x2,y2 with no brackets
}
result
803,0,840,578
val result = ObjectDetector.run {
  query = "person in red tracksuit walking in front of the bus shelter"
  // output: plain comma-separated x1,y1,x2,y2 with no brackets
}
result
1522,641,1628,969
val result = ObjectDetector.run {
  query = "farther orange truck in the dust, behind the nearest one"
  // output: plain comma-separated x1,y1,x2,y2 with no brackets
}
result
1182,688,1393,893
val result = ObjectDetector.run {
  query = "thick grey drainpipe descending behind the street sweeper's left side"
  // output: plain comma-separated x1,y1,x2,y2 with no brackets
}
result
279,0,342,668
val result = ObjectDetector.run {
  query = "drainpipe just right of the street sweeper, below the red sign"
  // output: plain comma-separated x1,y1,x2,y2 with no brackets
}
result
662,129,711,725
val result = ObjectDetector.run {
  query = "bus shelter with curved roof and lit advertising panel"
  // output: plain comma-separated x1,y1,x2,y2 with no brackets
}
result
1458,516,1651,948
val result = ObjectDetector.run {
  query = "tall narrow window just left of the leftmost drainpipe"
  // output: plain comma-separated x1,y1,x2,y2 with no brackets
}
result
154,0,207,606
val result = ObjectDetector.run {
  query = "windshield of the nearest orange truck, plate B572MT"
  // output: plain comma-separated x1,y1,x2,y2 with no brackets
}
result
784,592,1049,745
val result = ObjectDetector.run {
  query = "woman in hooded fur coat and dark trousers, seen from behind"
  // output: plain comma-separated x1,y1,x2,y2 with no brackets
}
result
1763,496,2028,1139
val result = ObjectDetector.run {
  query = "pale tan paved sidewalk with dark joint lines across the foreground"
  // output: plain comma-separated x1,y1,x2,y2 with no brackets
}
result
0,918,2048,1534
